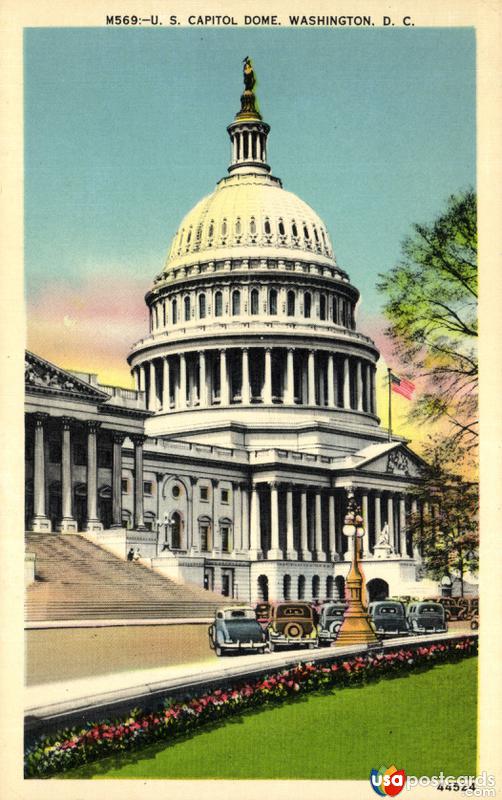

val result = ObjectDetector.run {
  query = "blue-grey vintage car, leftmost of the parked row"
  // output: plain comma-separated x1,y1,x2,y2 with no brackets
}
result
208,607,267,656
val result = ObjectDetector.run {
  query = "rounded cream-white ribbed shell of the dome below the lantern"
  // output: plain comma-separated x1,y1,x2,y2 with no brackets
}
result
164,173,335,273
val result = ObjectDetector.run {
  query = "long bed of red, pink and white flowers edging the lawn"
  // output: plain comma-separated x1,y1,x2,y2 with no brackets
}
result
25,636,477,778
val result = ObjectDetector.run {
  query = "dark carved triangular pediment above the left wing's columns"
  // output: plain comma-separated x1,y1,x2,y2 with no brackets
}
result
24,351,109,403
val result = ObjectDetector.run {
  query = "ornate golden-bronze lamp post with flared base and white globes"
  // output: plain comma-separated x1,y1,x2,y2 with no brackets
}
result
334,492,378,647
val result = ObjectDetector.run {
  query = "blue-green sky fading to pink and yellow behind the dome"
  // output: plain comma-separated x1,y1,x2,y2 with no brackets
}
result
24,28,476,444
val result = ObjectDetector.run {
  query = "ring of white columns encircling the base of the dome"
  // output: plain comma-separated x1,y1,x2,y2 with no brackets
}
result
133,347,376,414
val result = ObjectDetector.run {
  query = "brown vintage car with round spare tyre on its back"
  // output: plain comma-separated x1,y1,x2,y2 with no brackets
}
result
267,601,318,652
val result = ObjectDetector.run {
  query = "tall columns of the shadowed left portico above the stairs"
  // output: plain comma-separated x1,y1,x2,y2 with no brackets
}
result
28,413,146,532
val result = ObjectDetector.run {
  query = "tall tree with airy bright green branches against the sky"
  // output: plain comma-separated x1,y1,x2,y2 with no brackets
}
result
377,190,478,449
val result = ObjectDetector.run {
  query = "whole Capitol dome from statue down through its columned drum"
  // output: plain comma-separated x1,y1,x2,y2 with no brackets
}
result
128,61,379,446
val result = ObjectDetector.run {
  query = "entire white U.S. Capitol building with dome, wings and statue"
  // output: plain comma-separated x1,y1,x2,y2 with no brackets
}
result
25,63,431,600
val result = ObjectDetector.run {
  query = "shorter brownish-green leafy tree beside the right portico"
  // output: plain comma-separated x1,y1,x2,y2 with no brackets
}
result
409,440,479,596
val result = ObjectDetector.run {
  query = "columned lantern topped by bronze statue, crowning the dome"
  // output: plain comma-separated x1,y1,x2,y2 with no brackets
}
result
227,56,270,174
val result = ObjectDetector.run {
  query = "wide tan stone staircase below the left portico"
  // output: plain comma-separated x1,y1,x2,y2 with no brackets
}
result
26,533,236,622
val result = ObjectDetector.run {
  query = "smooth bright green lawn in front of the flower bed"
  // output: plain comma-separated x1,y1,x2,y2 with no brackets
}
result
61,658,477,780
